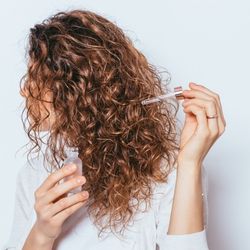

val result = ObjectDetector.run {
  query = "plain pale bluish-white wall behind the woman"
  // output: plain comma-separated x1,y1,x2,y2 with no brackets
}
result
0,0,250,250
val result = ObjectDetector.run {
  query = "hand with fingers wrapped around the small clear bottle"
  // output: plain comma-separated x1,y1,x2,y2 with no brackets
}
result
33,164,89,241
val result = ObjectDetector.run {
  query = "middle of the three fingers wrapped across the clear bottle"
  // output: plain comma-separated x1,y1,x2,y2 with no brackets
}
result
40,176,86,205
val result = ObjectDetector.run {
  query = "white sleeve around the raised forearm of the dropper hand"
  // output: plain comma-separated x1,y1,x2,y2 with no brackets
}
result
156,165,209,250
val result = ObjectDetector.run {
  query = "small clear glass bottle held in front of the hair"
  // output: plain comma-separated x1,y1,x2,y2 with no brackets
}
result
63,147,82,195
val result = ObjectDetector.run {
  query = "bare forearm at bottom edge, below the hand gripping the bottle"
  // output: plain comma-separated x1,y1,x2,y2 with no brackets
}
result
22,225,54,250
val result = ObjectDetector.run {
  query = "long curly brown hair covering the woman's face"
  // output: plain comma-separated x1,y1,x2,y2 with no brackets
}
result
20,10,179,236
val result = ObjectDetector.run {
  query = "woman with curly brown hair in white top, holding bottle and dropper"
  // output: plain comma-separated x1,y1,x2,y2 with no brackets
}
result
3,10,226,250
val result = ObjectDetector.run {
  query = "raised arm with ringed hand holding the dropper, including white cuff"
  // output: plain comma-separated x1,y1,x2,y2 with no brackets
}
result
155,83,226,250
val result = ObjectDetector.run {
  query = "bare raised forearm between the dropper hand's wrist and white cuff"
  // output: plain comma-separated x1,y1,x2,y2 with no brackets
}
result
167,163,204,234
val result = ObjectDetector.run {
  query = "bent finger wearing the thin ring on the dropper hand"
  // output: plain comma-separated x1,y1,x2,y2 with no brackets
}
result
182,98,219,137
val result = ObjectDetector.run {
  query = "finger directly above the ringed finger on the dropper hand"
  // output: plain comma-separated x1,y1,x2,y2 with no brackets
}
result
183,89,225,131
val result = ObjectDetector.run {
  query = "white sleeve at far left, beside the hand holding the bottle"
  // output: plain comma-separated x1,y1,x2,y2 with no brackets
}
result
3,163,36,250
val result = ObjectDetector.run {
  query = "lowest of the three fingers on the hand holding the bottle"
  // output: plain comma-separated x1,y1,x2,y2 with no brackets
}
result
48,191,89,217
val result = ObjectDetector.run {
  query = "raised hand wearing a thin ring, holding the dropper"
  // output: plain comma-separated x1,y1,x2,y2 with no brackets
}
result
178,83,226,165
